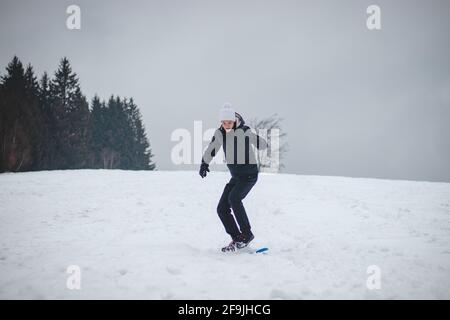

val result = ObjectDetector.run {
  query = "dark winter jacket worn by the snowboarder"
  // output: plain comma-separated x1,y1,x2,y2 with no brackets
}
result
202,112,267,176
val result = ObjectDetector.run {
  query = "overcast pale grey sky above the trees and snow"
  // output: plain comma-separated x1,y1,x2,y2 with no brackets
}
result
0,0,450,181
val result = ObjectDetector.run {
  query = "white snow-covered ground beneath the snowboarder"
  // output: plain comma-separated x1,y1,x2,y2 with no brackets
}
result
0,170,450,299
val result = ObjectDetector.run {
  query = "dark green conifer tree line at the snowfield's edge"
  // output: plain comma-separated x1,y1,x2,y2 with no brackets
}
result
0,56,155,172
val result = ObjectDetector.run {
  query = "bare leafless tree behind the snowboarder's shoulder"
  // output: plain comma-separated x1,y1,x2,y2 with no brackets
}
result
249,113,288,172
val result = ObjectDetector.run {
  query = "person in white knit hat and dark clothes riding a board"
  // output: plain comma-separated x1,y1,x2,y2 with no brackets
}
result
199,104,267,252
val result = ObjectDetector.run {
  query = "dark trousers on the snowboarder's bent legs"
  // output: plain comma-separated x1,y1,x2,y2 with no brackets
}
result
217,174,258,239
